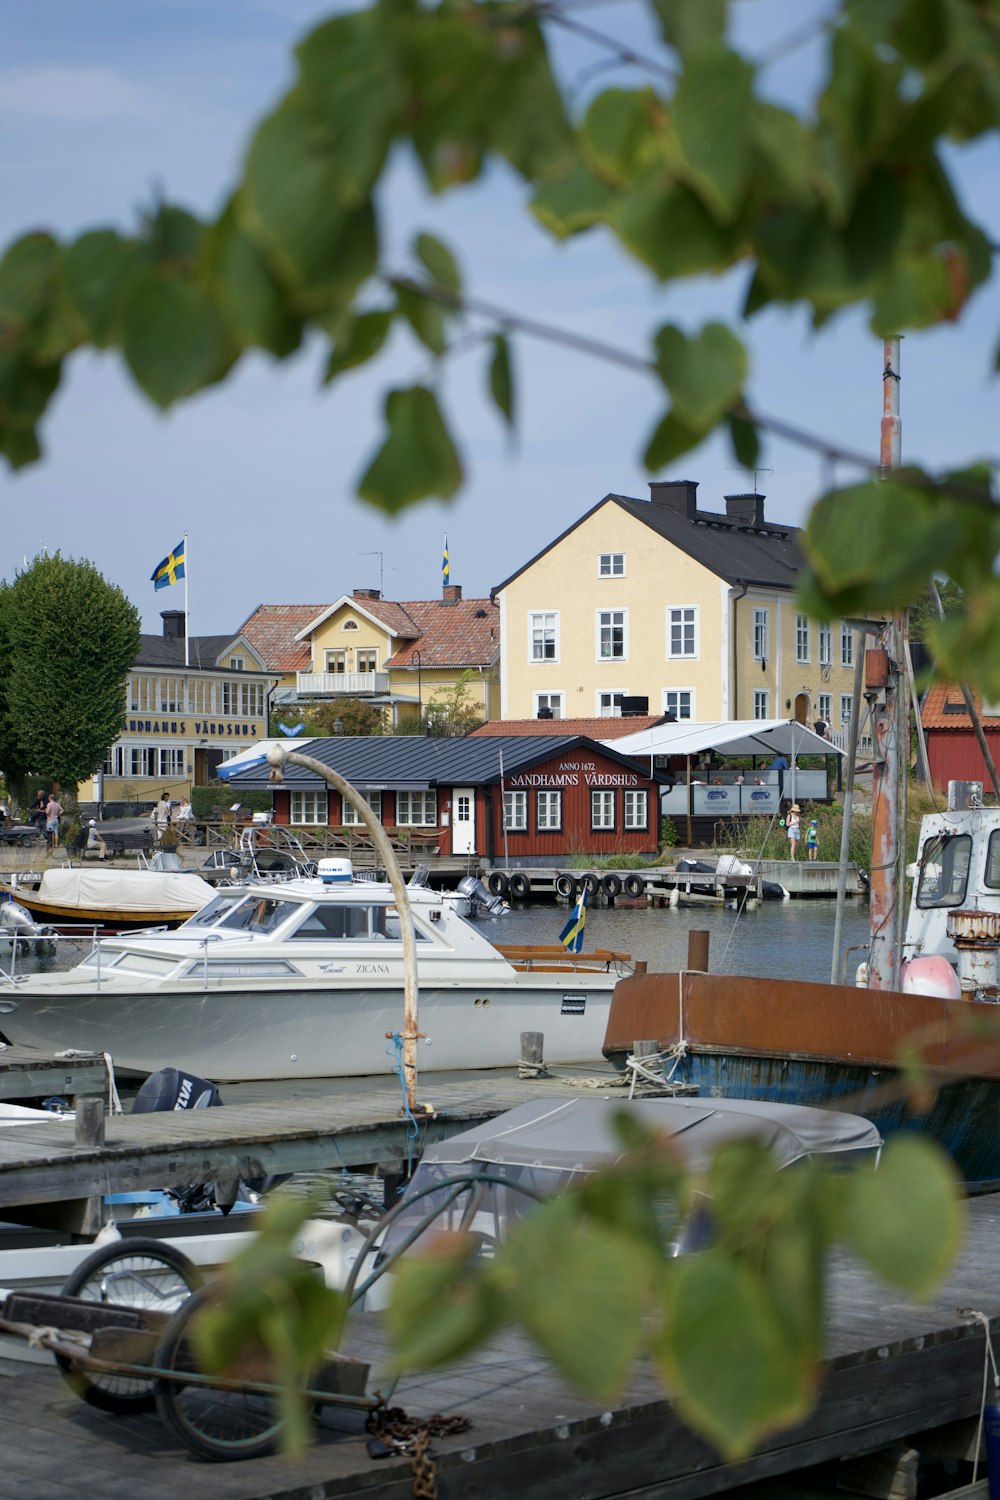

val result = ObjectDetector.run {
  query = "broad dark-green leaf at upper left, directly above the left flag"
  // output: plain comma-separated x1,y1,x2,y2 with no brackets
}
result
121,267,237,408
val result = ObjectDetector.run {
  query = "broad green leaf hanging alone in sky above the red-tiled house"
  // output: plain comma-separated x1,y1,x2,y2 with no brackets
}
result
358,386,462,513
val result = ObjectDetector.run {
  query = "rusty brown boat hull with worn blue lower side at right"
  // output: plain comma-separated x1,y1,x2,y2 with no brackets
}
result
603,974,1000,1190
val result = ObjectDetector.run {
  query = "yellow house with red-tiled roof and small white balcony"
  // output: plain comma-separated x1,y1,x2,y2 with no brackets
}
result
240,584,499,728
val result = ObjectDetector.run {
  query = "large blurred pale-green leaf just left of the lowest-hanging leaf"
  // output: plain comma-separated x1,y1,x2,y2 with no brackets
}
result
493,1196,651,1401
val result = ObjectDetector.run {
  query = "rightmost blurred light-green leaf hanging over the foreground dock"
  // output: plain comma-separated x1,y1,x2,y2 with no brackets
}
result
847,1134,964,1296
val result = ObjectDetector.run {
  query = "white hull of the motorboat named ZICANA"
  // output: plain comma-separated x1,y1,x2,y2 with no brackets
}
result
0,972,616,1082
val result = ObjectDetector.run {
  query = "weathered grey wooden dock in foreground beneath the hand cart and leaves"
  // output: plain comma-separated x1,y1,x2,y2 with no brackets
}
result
0,1199,1000,1500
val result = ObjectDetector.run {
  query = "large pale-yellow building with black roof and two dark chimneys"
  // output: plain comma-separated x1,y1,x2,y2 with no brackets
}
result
492,480,859,741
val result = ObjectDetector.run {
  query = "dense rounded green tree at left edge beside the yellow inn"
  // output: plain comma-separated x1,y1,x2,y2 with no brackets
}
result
0,552,139,797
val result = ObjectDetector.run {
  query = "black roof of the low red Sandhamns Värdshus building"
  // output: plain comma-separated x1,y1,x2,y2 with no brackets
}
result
226,735,660,791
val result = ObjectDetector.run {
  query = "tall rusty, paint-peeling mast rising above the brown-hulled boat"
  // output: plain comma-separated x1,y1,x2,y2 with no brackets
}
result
865,338,907,990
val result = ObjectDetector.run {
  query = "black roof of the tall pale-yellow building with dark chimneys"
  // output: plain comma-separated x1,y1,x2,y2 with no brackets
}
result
490,495,805,597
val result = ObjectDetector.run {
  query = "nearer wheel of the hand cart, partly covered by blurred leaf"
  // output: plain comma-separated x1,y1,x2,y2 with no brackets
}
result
156,1287,283,1463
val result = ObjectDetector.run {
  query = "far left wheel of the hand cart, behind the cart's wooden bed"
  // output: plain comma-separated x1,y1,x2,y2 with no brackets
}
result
55,1239,202,1415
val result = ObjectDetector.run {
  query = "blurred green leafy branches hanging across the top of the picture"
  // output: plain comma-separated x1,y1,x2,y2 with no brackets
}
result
0,0,1000,695
